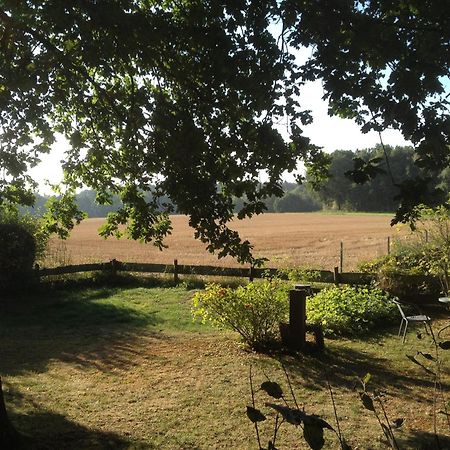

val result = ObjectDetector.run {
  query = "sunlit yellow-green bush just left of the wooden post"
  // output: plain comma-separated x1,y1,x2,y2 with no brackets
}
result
192,279,289,350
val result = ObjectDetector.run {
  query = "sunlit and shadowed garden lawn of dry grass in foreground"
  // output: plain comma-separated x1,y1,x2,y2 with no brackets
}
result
0,284,450,450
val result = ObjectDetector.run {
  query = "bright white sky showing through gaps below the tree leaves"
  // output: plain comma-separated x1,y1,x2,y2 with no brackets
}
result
30,80,410,194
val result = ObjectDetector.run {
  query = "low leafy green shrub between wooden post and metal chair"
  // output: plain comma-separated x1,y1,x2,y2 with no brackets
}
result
306,286,397,336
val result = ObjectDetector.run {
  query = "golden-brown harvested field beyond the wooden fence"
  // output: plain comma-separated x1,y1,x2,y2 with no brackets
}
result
45,213,407,271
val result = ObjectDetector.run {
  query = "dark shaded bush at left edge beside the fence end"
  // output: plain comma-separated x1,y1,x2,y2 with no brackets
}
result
0,223,36,290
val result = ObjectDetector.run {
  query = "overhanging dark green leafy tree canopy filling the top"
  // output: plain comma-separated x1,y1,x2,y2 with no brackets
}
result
0,0,450,262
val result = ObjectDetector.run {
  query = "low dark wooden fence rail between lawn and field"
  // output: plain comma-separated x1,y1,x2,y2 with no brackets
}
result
35,259,440,285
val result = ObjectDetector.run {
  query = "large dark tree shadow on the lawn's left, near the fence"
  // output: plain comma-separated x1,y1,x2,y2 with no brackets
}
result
0,286,167,375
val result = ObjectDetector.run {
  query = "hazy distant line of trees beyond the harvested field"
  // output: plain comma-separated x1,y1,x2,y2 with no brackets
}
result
31,146,450,217
